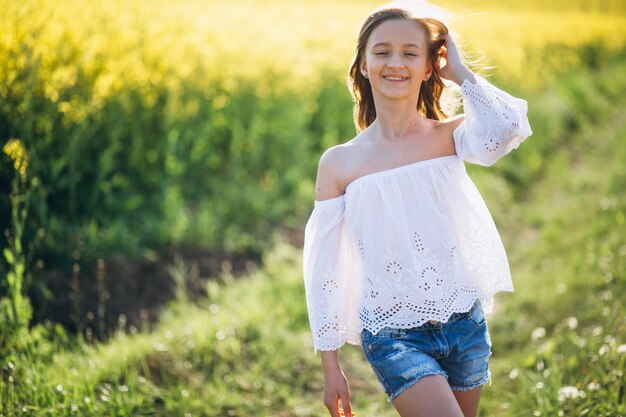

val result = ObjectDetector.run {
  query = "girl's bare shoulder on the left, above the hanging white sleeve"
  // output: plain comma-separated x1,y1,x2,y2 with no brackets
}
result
315,139,355,201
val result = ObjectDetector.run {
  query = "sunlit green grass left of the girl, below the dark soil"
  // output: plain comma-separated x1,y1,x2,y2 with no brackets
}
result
0,247,320,416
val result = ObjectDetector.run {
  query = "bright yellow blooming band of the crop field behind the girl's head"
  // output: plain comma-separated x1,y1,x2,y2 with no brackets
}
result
0,0,626,89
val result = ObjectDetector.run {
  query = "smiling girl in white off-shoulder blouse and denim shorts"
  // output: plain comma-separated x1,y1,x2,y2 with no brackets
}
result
304,1,531,417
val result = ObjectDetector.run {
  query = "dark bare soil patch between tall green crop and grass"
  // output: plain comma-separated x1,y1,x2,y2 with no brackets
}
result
31,248,261,339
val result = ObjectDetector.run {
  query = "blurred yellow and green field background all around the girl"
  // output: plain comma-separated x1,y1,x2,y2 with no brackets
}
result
0,0,626,417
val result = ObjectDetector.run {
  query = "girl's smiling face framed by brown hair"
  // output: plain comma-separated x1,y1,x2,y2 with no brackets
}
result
361,19,431,102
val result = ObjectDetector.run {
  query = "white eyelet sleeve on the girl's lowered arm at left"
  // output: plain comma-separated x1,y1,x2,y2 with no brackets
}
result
303,196,362,351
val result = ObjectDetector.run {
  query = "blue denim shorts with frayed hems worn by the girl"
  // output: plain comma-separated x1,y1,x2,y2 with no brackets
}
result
361,301,491,402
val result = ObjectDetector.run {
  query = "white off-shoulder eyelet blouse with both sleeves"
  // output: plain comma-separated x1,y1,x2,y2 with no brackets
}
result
303,76,532,350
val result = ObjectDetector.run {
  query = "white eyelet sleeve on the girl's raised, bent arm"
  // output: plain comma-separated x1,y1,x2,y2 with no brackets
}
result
453,75,532,166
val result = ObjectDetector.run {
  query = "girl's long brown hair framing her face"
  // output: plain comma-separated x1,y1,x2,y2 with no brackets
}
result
348,8,449,132
